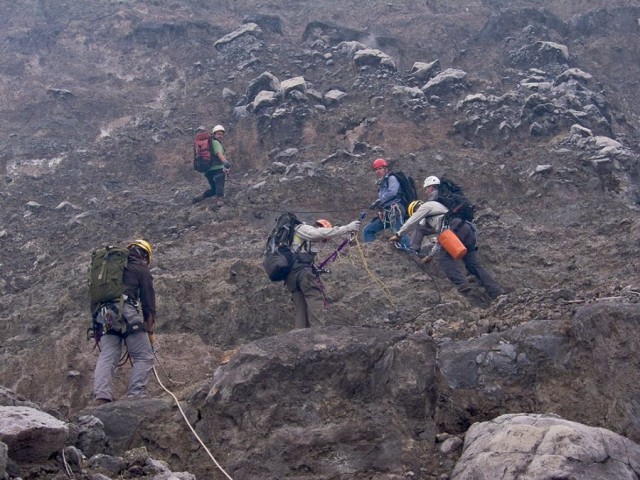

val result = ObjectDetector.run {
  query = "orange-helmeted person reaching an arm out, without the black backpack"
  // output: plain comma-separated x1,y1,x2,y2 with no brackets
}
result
284,219,360,328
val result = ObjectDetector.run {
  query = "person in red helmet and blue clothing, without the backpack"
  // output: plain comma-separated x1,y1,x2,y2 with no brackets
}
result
362,158,408,245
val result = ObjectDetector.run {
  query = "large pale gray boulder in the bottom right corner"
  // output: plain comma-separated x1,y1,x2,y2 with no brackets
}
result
451,414,640,480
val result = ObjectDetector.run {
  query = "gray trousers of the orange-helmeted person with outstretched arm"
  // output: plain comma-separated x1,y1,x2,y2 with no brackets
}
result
285,268,326,328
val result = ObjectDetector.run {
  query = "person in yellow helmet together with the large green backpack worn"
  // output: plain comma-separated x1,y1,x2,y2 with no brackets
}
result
89,239,156,405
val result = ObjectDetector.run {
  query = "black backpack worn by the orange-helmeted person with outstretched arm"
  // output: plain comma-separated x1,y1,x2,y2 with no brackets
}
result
262,212,302,282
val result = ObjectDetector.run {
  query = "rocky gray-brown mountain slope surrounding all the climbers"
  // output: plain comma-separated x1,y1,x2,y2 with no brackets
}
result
0,0,640,479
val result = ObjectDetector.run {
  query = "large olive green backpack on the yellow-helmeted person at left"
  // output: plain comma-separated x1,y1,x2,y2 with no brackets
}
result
89,245,129,313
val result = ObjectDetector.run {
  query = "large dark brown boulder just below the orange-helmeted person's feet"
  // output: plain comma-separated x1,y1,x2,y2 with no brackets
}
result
193,327,436,479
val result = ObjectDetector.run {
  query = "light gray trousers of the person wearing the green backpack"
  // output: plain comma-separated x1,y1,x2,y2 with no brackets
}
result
93,303,154,400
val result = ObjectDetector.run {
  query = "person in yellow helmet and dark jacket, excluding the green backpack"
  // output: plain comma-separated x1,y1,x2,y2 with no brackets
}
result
93,240,156,405
